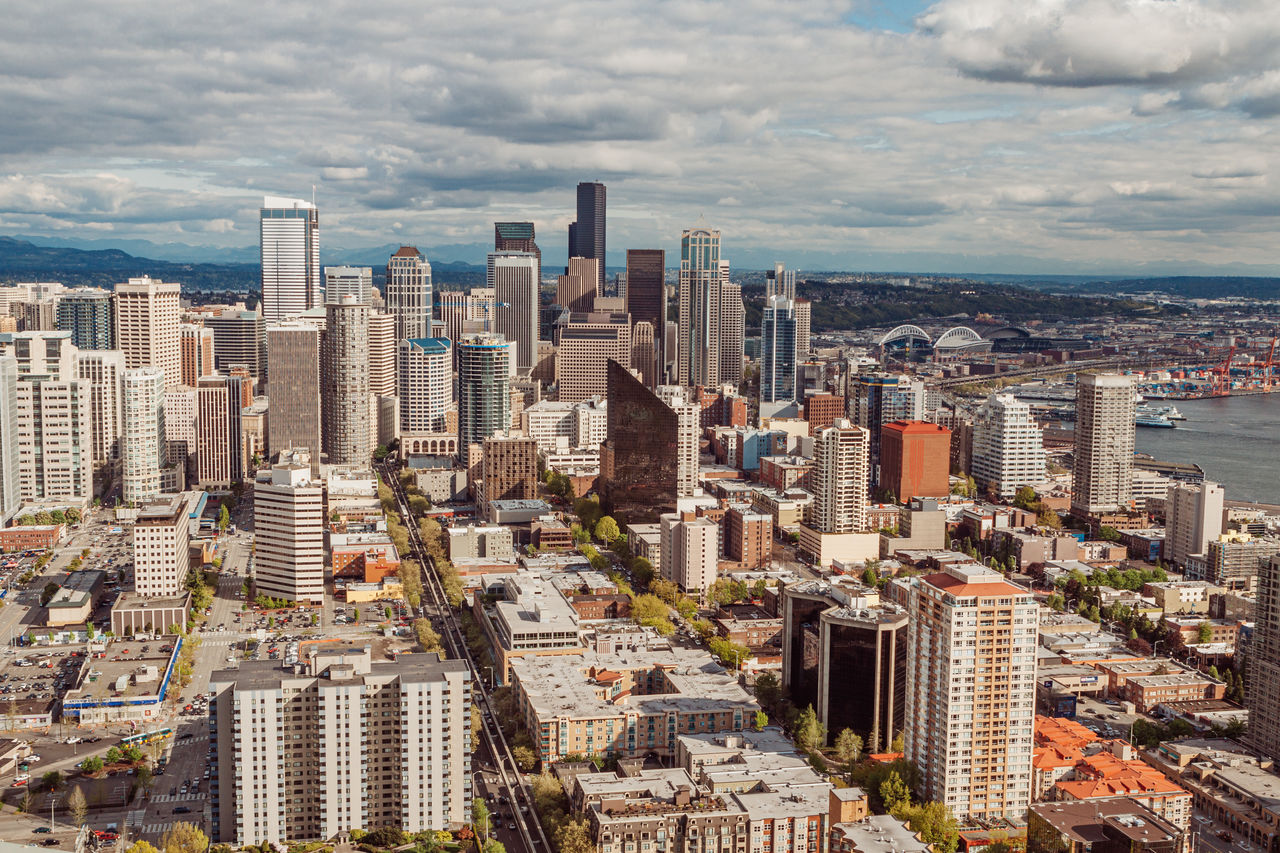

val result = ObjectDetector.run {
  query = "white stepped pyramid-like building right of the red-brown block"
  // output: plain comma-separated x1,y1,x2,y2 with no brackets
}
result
969,394,1044,500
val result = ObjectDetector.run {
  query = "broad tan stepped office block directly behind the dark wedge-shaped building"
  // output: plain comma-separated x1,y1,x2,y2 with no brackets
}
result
553,311,631,402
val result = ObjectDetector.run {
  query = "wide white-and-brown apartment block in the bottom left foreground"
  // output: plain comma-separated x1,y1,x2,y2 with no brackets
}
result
210,642,471,847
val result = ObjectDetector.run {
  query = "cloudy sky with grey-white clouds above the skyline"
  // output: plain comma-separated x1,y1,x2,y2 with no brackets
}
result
0,0,1280,274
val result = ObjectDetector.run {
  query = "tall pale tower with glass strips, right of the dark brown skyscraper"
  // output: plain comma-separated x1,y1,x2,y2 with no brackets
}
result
676,228,722,387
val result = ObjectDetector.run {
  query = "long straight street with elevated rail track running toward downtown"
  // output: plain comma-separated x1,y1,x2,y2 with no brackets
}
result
380,462,552,853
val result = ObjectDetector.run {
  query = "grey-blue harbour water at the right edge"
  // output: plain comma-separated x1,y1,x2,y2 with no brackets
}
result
1137,393,1280,503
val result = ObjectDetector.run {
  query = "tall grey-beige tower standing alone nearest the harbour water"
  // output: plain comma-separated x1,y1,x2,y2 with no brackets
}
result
1071,374,1137,516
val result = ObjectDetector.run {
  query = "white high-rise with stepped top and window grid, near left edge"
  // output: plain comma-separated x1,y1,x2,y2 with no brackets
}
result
0,332,93,506
